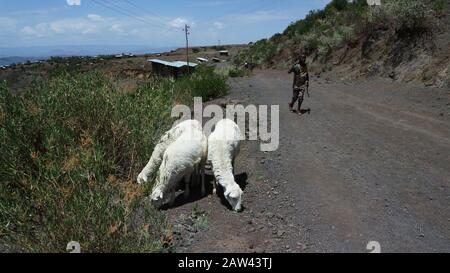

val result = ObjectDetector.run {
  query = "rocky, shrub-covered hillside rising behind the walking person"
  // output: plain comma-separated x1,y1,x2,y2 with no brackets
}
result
235,0,450,87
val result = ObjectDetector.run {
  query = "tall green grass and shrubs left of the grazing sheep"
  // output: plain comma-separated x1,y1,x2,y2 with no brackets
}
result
0,65,228,252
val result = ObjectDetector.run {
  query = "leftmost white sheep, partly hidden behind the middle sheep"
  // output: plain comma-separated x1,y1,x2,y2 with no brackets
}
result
137,120,202,184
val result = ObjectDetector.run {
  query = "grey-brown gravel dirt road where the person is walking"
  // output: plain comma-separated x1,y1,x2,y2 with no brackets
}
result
167,71,450,252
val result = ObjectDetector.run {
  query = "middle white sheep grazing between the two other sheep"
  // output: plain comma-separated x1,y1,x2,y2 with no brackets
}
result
151,127,208,205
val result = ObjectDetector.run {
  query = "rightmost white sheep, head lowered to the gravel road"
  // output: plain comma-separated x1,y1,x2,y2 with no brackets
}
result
208,119,243,211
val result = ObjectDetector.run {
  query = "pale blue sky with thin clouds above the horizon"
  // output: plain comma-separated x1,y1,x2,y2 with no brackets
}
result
0,0,329,51
